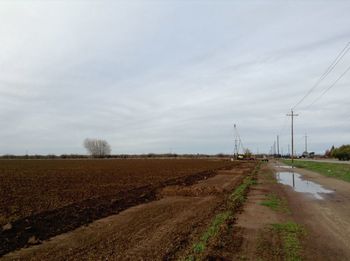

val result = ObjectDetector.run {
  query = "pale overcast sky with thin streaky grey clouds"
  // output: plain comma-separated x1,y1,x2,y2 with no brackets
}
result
0,0,350,155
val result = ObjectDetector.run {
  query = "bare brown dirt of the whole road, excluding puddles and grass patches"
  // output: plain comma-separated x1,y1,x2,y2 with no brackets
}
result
210,160,350,261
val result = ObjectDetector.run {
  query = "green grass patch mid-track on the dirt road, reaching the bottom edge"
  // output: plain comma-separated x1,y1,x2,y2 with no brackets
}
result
271,222,305,261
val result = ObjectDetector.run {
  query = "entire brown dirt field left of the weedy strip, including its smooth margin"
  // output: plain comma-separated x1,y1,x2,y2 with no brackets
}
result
0,157,255,259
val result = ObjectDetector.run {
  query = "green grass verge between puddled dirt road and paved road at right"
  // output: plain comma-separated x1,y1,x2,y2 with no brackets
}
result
282,160,350,182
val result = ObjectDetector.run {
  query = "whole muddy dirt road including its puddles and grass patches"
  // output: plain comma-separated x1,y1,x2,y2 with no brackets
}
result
215,162,350,261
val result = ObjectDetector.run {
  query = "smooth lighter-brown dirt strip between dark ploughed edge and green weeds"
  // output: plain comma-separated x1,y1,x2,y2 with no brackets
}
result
3,162,255,260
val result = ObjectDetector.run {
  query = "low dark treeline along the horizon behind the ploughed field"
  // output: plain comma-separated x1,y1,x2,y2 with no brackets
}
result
0,153,232,159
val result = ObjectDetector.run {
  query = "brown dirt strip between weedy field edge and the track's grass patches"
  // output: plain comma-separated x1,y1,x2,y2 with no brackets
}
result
202,161,287,260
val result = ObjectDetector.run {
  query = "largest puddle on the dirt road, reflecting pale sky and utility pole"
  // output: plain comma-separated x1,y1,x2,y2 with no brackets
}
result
276,171,334,199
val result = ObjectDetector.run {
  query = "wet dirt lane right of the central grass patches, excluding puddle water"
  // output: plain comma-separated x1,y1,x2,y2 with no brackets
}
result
274,161,350,260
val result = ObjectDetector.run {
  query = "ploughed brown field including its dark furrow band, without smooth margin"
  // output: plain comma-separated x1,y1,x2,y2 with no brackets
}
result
0,159,238,256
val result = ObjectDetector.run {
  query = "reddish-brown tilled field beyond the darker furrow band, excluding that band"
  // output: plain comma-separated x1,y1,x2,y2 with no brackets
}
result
0,159,235,226
